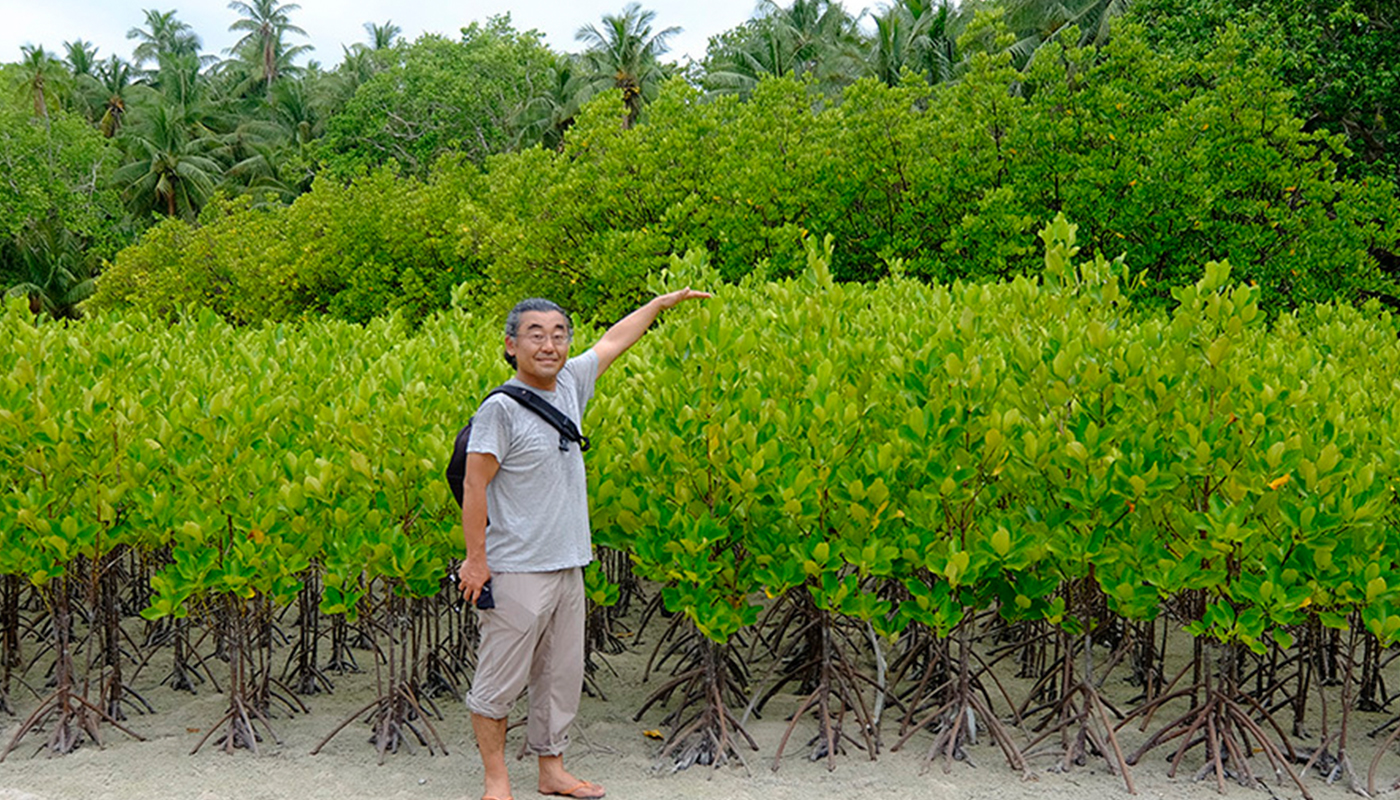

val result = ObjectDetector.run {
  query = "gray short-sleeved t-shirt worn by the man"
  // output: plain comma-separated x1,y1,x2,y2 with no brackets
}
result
466,350,598,572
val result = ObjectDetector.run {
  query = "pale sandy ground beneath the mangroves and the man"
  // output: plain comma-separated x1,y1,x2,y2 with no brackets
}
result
0,619,1400,800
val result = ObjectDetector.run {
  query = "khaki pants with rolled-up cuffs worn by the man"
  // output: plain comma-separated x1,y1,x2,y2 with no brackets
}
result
466,567,584,755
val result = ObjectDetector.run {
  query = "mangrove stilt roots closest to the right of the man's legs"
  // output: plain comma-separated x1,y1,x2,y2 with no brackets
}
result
633,610,759,772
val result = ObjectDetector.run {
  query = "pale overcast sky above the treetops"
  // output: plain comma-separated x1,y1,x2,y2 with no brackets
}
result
0,0,865,67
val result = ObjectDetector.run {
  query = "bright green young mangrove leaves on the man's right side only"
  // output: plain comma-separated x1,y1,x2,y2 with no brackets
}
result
595,220,1400,650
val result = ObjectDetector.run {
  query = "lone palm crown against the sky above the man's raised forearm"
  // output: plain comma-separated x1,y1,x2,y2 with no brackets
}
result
574,3,680,127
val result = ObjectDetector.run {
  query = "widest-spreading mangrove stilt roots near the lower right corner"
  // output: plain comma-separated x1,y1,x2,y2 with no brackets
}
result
1119,642,1312,800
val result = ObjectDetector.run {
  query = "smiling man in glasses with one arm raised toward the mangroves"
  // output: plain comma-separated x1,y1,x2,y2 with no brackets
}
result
458,289,710,800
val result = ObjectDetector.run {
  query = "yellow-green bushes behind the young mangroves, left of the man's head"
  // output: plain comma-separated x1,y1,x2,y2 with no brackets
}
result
91,170,475,322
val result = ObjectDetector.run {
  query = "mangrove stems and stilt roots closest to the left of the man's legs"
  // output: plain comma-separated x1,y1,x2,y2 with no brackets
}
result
311,588,448,764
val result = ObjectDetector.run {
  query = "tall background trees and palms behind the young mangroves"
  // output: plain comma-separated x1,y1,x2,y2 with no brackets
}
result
0,0,1396,321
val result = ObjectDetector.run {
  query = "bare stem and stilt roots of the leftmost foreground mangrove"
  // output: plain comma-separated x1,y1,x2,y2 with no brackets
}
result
0,576,146,761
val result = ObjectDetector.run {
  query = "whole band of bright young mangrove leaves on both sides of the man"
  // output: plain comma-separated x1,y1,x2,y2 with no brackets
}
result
0,217,1400,773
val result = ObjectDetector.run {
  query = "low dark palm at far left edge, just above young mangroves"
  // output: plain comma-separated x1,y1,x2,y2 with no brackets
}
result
4,216,95,319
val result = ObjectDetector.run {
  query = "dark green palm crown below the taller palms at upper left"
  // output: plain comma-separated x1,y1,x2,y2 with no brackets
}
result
112,104,223,219
